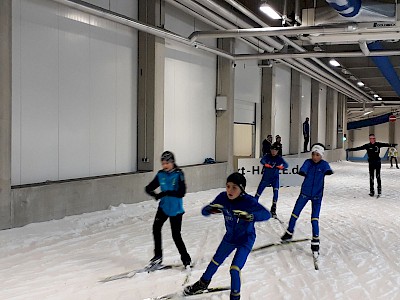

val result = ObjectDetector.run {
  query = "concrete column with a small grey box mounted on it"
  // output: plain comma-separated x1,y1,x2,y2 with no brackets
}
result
215,39,235,173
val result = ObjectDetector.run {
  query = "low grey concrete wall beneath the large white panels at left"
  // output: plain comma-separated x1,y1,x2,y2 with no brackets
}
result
10,163,227,229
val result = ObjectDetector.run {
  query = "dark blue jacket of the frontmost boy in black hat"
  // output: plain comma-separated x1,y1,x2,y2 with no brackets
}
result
201,192,271,250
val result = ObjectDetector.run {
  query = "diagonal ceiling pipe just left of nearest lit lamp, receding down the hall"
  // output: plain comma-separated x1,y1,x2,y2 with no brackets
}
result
220,0,374,101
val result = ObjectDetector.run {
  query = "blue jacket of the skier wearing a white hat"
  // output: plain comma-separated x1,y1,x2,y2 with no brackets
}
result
299,159,333,199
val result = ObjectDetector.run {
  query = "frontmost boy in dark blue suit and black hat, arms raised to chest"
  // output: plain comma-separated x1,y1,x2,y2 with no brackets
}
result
184,173,271,300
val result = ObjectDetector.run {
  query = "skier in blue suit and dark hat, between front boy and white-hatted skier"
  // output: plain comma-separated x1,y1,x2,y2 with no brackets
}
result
254,145,289,218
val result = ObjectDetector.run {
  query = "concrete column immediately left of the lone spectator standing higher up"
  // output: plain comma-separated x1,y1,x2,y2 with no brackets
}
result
289,69,303,154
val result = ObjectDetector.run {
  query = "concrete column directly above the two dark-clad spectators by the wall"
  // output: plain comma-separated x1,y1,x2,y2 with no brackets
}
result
260,67,275,144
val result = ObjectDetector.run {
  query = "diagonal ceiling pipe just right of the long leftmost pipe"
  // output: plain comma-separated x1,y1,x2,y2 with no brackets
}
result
170,0,274,52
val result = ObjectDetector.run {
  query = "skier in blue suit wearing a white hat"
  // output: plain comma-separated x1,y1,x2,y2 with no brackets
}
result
281,143,333,252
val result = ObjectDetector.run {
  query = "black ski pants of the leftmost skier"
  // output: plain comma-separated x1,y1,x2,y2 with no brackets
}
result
153,207,190,261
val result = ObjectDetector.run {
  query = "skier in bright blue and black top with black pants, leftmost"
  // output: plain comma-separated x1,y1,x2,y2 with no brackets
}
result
145,151,191,267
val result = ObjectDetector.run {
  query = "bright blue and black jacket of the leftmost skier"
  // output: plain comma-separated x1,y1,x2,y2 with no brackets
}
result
145,168,186,217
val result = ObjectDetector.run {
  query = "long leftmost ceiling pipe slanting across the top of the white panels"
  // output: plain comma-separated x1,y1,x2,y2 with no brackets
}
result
52,0,233,60
